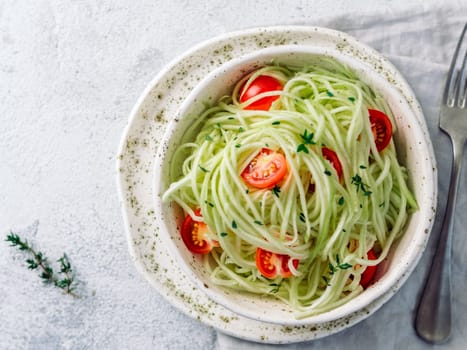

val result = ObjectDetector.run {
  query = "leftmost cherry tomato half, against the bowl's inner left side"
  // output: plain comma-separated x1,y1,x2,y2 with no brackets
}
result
181,209,215,254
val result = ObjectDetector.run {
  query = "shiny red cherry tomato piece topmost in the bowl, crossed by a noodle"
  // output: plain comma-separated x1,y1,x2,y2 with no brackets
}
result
240,75,282,111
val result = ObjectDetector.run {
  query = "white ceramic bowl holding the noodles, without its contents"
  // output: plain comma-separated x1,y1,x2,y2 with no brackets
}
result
154,45,436,325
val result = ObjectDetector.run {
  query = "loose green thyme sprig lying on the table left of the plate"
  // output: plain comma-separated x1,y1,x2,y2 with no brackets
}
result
5,231,78,297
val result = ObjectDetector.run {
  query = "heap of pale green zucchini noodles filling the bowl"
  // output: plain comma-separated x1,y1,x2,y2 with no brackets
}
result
163,59,417,318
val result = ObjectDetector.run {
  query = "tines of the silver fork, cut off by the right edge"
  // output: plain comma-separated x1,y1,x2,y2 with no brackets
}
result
443,23,467,107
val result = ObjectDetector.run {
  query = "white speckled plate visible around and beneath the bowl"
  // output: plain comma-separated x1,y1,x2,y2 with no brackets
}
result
117,26,437,343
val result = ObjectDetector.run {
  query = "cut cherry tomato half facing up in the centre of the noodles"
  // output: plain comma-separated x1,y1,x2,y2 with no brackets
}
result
241,148,287,188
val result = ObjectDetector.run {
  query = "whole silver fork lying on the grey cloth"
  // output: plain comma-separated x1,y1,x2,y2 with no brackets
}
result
415,23,467,344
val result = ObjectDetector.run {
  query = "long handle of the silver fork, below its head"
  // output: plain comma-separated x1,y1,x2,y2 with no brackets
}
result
415,137,465,344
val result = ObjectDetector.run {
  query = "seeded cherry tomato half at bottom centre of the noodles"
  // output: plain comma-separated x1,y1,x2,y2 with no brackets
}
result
256,248,299,279
